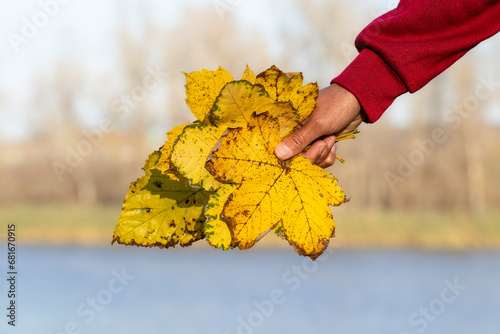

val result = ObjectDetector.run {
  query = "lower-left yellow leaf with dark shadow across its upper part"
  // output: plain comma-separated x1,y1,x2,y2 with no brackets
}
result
113,151,209,248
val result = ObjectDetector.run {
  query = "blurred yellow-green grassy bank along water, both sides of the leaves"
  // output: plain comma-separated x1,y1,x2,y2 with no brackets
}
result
0,204,500,250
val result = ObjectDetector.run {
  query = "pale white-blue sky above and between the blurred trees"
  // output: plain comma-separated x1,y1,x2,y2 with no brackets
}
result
0,0,500,140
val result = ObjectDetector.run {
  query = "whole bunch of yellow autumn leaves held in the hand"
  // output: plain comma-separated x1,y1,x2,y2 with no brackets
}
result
113,66,346,259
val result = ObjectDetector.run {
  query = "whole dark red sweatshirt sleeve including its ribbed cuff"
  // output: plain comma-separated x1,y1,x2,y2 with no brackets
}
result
332,0,500,122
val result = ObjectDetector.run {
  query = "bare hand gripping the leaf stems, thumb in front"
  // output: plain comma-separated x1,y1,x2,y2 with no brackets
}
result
274,84,363,168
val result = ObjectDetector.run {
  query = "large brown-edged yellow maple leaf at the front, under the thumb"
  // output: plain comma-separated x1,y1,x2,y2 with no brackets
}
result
206,113,345,259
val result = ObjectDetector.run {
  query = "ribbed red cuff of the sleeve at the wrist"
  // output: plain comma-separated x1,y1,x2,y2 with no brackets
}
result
331,49,408,123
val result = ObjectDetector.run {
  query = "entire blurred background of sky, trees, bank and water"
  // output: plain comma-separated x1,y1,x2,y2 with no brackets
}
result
0,0,500,333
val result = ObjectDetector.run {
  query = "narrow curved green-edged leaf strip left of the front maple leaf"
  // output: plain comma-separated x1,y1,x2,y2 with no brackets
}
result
204,184,237,250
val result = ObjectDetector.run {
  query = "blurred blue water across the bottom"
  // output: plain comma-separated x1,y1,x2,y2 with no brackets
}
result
0,245,500,334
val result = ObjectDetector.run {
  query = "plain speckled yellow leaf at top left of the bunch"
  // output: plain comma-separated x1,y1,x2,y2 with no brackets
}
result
184,67,233,121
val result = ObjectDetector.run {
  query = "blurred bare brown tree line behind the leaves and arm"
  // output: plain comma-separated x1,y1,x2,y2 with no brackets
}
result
0,1,500,213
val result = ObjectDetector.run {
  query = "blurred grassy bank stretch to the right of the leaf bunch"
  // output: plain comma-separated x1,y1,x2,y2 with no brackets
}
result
335,211,500,250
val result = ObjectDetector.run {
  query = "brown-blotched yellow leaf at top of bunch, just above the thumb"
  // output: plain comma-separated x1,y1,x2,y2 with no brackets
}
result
255,66,319,122
